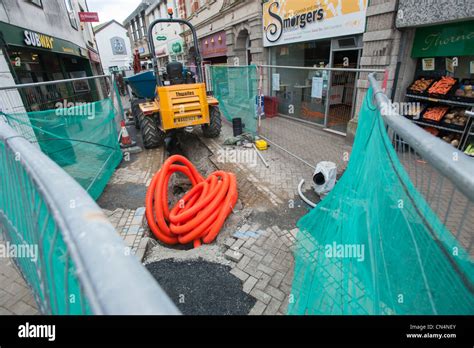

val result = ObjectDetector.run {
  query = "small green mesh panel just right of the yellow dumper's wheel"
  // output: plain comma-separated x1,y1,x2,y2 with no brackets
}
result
209,65,258,133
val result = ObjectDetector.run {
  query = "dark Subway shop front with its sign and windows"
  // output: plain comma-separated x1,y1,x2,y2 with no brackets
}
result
0,22,92,110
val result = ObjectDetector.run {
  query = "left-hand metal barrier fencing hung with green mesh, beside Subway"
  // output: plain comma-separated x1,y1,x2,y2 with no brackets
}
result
0,76,178,314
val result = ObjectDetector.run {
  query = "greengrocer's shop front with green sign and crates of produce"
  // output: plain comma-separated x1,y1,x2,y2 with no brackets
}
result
400,20,474,156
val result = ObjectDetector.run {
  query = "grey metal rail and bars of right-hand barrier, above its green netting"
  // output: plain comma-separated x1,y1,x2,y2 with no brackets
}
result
369,74,474,256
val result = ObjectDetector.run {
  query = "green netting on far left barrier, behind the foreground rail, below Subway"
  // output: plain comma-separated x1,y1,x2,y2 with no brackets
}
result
3,99,122,199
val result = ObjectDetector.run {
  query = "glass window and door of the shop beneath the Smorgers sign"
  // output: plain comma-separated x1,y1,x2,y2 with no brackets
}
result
269,37,360,134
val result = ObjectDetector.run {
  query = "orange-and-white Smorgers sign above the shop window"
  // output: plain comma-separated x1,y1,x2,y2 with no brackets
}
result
263,0,368,47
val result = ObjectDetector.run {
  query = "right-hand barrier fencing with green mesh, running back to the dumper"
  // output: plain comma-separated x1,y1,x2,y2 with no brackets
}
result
209,66,474,314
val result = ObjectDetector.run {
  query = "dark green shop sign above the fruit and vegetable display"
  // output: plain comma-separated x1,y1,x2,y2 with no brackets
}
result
412,21,474,58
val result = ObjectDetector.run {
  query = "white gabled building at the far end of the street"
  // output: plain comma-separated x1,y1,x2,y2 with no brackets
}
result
94,20,133,73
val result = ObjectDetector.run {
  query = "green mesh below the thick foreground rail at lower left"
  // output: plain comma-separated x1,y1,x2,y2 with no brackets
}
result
0,137,91,314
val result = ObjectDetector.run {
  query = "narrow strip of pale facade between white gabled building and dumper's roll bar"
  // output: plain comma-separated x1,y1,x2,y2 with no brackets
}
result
123,0,151,69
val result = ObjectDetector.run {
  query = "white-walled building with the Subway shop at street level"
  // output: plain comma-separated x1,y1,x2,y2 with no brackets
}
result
0,0,99,87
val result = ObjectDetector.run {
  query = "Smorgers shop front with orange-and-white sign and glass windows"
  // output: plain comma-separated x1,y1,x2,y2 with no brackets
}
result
263,0,367,133
